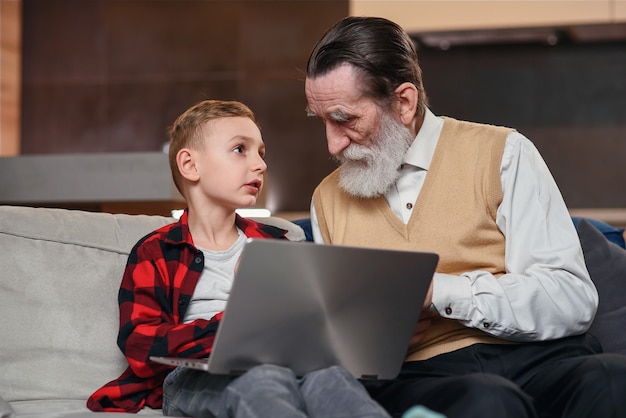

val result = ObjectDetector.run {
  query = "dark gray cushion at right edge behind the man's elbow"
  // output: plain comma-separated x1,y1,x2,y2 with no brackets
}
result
577,219,626,354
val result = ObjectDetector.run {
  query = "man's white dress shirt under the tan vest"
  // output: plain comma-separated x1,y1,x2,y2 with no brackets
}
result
311,110,598,341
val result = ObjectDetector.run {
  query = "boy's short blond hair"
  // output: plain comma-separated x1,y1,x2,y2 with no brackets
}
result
168,100,260,196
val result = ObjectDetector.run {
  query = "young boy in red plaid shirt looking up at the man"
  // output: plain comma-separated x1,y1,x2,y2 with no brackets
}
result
87,100,388,418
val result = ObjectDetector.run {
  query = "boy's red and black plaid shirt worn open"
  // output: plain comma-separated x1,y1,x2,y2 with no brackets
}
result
87,211,286,412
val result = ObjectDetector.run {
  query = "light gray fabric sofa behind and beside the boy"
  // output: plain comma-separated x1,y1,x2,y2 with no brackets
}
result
0,206,305,418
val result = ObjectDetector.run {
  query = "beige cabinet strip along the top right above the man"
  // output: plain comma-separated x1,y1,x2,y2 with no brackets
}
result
350,0,626,32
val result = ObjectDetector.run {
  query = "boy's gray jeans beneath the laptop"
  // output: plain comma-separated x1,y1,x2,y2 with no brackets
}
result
163,364,389,418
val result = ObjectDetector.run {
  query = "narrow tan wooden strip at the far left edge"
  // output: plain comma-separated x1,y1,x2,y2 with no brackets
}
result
0,0,22,156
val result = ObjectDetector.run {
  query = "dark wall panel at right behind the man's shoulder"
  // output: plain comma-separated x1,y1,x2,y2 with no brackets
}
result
418,41,626,208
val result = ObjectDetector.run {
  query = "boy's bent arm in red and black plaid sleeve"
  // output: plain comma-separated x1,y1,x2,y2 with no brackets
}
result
118,241,221,378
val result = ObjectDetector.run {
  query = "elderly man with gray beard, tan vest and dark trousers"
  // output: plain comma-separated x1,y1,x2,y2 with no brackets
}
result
305,17,626,418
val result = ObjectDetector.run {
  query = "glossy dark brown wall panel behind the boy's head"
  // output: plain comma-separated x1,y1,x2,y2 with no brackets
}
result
22,0,348,211
